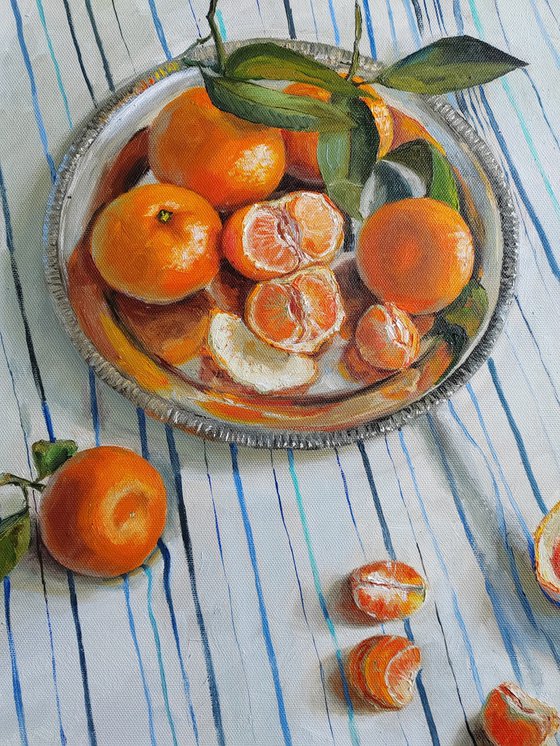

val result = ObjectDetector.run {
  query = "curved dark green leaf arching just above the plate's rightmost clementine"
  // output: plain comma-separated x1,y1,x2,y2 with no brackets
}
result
384,139,459,210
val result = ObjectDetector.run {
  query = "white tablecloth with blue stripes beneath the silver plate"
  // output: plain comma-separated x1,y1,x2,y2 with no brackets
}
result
0,0,560,746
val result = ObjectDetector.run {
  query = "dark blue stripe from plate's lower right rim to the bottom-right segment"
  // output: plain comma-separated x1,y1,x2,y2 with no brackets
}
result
427,414,523,684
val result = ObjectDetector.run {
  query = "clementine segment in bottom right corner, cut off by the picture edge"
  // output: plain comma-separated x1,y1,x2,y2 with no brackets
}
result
482,682,560,746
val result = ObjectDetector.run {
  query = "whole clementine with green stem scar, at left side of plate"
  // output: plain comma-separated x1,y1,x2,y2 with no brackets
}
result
91,184,222,303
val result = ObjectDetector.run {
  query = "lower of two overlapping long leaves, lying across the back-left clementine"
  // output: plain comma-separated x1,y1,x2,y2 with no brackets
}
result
201,70,353,132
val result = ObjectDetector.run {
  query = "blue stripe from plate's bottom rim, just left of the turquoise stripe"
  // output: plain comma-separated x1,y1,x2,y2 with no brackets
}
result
230,443,292,745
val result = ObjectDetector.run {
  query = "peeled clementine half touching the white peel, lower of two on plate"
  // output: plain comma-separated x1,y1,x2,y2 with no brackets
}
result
245,267,344,353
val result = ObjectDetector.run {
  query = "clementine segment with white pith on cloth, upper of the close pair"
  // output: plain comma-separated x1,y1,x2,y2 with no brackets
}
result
350,560,427,622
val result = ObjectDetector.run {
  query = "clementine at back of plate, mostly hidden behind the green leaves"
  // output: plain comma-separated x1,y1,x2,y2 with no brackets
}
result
282,79,393,184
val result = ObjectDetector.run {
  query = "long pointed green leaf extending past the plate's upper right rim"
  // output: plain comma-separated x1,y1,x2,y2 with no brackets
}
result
376,36,527,93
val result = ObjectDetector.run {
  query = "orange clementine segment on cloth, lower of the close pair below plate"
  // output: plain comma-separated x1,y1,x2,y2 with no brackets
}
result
347,635,421,709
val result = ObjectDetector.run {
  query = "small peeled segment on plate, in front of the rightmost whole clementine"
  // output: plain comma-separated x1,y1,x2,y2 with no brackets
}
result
355,303,420,370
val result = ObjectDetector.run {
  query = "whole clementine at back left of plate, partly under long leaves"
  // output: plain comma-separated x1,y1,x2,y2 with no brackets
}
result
148,87,285,210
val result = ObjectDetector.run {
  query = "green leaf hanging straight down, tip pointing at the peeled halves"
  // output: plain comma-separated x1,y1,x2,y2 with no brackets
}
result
317,99,379,220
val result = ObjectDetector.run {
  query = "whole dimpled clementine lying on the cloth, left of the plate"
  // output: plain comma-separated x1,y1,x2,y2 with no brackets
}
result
39,446,167,577
